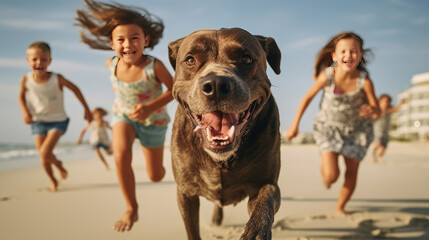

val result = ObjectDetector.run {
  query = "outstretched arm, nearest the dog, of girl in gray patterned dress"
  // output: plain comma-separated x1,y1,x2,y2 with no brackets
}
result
286,72,328,141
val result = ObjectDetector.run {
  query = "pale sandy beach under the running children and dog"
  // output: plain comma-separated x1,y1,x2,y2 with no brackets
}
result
0,142,429,240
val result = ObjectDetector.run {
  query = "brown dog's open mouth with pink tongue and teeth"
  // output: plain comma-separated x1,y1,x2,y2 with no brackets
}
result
185,101,257,151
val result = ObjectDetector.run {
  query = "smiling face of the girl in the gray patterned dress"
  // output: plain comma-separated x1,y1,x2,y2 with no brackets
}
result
331,38,362,72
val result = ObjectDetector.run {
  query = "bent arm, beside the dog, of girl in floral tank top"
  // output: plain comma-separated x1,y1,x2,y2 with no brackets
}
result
128,60,173,122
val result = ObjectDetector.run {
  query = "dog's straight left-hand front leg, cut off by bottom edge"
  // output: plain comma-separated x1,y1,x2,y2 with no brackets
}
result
177,189,201,240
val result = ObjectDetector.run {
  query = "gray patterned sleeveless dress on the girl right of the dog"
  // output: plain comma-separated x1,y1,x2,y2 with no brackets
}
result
313,67,374,160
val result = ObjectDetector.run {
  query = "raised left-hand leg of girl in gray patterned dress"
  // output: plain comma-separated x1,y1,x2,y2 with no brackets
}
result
320,151,340,188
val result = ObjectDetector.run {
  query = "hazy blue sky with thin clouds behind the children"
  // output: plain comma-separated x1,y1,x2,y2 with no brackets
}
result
0,0,429,143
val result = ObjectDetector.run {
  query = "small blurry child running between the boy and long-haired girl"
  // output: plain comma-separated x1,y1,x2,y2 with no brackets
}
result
77,108,113,170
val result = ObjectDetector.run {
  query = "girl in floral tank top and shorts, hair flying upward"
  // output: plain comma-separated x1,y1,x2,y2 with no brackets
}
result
77,0,173,232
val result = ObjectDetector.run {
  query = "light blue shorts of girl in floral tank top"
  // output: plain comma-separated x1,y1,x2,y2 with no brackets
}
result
111,114,167,148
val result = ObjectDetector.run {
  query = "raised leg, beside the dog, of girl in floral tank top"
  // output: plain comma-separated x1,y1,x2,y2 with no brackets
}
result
142,146,165,182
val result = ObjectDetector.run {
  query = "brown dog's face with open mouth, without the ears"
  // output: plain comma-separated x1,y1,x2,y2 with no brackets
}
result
169,29,271,161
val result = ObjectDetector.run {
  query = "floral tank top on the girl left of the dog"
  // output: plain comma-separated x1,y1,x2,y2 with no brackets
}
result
109,56,170,126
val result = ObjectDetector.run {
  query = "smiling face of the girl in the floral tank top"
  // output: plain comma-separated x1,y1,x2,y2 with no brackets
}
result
110,24,149,65
